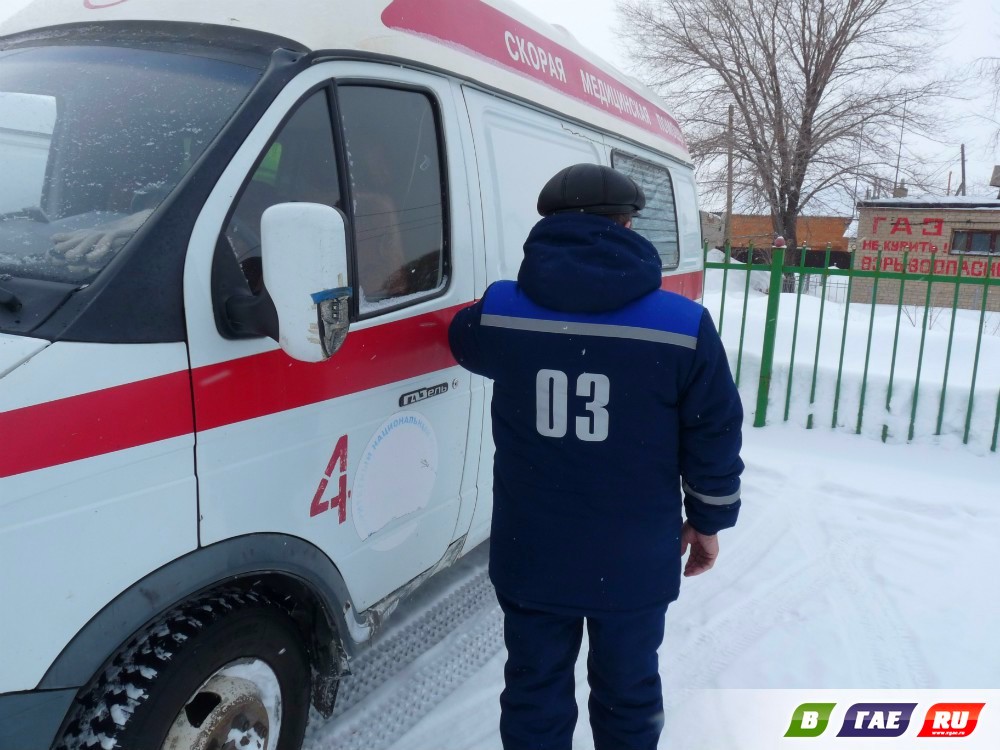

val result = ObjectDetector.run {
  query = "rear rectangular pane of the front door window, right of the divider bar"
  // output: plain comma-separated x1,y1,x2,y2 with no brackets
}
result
338,84,447,316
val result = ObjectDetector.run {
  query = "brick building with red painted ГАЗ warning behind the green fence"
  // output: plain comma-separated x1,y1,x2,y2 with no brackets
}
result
851,196,1000,311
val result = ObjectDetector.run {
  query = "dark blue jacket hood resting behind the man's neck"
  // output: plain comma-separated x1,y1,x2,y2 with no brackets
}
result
517,213,661,312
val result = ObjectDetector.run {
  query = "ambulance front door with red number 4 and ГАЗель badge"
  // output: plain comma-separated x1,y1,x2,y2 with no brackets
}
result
185,62,473,609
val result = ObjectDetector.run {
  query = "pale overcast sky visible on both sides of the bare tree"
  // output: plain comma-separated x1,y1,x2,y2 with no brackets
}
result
514,0,1000,206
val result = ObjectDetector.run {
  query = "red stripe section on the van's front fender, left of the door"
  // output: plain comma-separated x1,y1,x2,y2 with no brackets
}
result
0,371,194,478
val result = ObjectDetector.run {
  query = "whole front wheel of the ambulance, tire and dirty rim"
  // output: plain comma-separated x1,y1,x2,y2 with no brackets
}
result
57,590,310,750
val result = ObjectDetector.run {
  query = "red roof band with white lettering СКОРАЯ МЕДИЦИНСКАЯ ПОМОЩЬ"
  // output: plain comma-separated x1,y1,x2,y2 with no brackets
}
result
382,0,686,148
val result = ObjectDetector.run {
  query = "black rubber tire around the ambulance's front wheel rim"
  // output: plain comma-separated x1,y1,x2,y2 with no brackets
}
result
56,590,311,750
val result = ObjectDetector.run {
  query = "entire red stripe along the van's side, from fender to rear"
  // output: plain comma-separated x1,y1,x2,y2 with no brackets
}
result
0,272,702,478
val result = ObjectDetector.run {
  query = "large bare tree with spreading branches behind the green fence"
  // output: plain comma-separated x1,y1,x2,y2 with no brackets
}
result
618,0,949,247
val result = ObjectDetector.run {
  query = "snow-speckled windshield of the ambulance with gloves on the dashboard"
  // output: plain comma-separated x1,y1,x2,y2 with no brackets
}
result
0,46,261,284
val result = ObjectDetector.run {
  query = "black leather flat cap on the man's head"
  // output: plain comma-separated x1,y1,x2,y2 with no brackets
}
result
538,164,646,216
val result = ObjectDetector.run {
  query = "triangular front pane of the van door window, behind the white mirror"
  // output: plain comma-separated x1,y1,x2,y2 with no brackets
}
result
224,90,340,293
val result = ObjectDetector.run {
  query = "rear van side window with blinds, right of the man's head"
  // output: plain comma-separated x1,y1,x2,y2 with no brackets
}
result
611,151,680,270
